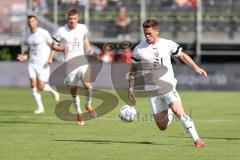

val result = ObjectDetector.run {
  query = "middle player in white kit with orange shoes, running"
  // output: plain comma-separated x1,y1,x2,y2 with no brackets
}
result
52,9,97,126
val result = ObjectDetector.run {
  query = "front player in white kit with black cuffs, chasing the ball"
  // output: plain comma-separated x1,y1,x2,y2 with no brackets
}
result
128,19,207,147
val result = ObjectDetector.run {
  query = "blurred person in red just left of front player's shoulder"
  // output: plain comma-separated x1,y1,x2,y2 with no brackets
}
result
119,41,133,64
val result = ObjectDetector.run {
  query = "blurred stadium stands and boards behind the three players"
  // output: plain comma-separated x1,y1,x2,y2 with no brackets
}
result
0,0,240,90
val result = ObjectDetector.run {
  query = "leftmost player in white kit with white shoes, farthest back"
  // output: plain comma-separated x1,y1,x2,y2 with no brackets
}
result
17,15,59,114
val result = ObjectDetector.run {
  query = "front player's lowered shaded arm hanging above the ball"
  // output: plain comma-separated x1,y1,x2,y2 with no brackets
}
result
128,63,137,104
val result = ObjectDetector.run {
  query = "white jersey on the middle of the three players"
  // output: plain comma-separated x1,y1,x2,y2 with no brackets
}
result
53,24,88,61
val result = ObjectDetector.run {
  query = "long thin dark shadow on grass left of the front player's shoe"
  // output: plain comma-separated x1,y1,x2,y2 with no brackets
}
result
53,139,192,146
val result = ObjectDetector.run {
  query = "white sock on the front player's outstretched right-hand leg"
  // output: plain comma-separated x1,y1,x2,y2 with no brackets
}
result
180,115,200,142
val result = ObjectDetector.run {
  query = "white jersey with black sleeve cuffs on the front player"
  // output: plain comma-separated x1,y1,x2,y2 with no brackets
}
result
132,38,182,86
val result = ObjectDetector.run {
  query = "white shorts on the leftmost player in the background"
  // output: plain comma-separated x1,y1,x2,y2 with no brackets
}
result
28,63,50,82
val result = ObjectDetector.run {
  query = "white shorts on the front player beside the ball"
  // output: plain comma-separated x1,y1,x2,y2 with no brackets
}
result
149,89,181,114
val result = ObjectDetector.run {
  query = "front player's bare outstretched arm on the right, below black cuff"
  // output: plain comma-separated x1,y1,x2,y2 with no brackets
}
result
179,52,207,78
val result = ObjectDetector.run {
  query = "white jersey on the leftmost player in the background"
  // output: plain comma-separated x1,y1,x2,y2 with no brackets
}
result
26,27,52,66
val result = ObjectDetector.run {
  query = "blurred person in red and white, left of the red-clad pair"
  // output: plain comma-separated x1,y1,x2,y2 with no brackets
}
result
99,43,114,63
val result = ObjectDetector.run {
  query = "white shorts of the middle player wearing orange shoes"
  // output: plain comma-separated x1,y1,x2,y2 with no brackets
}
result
64,65,88,86
